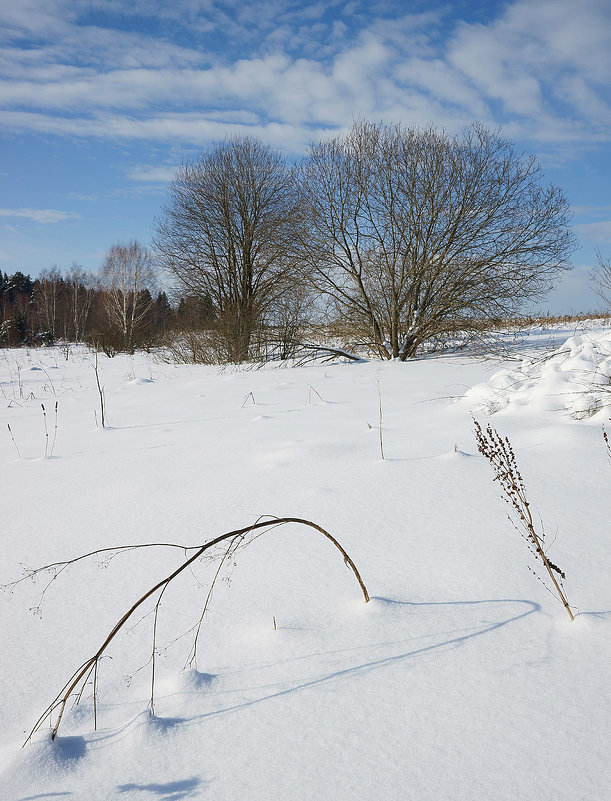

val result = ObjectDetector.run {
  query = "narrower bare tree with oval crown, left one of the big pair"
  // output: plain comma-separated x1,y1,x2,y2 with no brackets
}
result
154,137,295,362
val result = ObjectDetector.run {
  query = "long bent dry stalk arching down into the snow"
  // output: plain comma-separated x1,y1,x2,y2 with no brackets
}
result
20,517,369,745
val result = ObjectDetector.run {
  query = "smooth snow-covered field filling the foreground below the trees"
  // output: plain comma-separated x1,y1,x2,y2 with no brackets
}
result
0,326,611,801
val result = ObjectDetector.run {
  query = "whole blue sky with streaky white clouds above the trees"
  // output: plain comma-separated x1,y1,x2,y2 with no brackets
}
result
0,0,611,312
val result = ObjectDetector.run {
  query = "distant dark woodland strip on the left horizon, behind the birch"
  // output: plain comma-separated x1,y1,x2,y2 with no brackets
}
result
0,265,179,354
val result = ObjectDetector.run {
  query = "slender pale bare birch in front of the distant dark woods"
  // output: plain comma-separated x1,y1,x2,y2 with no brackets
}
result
100,240,155,353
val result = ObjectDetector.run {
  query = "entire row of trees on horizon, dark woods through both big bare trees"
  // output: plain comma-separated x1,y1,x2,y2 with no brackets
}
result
0,121,575,363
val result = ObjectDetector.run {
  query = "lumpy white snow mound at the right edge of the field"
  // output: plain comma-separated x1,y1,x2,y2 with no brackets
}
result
464,331,611,420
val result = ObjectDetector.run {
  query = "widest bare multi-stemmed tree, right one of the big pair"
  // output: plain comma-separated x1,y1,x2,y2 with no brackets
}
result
298,122,574,360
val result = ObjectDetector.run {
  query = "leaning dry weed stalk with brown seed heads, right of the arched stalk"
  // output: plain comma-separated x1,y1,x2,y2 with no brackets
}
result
473,419,574,620
